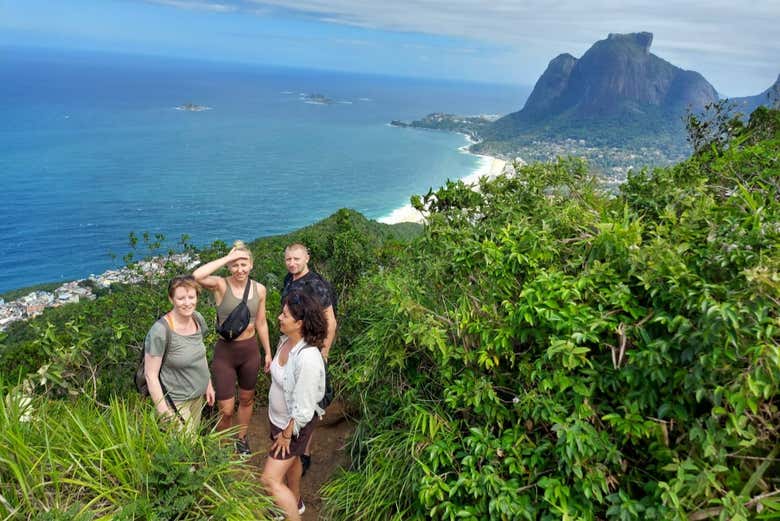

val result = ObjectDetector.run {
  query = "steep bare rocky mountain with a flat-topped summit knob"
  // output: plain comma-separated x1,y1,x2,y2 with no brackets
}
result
482,32,718,146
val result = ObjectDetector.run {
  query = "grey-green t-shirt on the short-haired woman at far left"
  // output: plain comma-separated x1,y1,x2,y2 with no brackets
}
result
144,311,209,402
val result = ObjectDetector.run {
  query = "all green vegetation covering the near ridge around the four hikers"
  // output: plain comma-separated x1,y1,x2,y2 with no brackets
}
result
0,108,780,520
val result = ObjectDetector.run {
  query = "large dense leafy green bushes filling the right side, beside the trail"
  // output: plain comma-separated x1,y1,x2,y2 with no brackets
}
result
323,109,780,520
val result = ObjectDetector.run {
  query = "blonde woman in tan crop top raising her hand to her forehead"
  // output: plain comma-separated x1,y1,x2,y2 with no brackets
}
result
192,241,272,455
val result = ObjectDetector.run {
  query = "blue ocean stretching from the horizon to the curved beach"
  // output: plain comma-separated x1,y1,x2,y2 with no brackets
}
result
0,48,528,292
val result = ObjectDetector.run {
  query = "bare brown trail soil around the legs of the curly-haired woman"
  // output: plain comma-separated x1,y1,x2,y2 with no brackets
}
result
249,400,355,521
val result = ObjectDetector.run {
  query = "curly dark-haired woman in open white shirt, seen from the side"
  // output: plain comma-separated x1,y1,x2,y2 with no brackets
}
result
261,291,328,521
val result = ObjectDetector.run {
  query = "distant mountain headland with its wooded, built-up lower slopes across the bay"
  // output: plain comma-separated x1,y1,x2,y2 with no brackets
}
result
390,32,780,185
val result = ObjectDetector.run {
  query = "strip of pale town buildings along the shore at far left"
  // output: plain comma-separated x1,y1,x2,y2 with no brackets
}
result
0,253,198,331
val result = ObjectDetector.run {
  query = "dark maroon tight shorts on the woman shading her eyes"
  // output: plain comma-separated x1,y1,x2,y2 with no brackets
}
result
211,336,260,400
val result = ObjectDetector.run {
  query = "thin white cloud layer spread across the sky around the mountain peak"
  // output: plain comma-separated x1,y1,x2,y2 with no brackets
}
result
146,0,780,94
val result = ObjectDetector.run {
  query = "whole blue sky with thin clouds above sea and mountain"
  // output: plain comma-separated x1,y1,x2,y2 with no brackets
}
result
0,0,780,96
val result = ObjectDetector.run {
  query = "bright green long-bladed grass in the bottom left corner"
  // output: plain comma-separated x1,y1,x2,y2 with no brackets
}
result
0,387,272,521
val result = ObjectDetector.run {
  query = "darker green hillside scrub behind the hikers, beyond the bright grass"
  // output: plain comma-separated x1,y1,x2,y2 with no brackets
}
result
0,210,420,403
